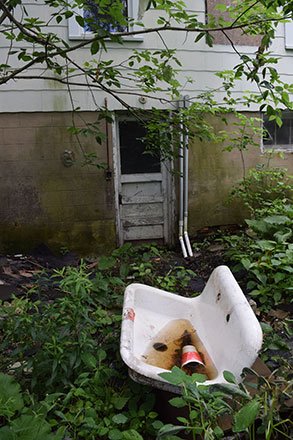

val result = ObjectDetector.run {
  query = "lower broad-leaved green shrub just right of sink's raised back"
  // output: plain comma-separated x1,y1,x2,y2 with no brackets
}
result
225,205,293,310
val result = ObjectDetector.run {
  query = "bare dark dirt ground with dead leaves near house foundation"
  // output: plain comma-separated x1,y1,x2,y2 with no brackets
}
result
0,230,293,369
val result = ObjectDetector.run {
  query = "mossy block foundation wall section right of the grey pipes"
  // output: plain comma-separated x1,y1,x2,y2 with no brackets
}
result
189,113,293,234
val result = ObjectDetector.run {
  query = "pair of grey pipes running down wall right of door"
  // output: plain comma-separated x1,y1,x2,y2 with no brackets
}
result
179,96,193,258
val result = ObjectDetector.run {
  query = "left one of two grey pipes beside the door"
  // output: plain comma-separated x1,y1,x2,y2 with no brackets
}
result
178,100,187,258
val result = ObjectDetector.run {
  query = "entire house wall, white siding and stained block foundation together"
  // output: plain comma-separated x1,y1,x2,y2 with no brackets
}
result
0,0,293,254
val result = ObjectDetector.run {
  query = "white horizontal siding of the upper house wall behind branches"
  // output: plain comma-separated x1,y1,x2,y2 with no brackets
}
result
0,0,293,112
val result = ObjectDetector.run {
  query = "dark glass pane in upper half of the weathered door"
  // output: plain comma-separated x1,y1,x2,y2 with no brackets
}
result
119,121,161,174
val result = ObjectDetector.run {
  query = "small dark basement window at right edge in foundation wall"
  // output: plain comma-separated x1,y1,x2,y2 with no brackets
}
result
263,112,293,151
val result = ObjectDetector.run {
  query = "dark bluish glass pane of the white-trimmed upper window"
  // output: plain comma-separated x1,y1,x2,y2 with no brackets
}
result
83,0,127,32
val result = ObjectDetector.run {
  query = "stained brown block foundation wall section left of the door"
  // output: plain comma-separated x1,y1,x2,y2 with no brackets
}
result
0,112,116,254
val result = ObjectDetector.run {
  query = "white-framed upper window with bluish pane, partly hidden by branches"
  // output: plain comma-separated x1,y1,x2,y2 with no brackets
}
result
69,0,142,40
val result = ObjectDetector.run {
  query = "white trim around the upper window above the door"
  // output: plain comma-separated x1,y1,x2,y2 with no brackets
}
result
68,0,143,41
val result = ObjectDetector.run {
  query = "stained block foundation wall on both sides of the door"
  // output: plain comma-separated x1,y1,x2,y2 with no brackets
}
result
0,112,293,255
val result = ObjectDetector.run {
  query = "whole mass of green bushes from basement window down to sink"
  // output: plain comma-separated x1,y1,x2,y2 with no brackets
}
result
225,169,293,310
